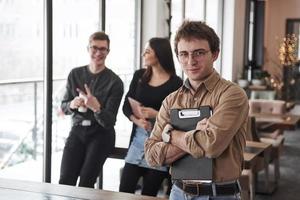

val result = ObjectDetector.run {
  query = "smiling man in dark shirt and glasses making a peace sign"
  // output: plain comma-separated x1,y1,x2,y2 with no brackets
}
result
59,32,124,188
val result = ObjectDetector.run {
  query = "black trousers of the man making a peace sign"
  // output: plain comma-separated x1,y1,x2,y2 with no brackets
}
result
59,124,115,188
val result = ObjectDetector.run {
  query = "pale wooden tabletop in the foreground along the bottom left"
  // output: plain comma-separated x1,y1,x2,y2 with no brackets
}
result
0,178,163,200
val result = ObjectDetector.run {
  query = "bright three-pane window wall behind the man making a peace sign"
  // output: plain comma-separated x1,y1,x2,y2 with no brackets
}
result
0,0,139,189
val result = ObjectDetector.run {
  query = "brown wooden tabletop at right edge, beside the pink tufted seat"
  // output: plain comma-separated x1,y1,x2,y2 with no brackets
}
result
250,113,300,130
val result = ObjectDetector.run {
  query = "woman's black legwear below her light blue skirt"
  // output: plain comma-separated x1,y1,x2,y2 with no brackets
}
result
119,163,169,196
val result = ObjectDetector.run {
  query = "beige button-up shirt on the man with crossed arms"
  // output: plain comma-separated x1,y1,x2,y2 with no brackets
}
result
145,71,249,182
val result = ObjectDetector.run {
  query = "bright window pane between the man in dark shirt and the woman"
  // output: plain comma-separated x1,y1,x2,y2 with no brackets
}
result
105,0,139,148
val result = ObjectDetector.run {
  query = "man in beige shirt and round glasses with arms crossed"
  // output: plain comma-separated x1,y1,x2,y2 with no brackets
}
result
145,21,249,200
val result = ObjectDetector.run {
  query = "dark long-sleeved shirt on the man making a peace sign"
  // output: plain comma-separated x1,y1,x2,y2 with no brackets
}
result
61,66,124,130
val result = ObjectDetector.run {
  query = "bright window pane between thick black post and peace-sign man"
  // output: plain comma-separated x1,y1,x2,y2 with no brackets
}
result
51,0,100,183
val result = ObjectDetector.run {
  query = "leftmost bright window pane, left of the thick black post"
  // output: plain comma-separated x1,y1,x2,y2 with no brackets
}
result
0,0,43,181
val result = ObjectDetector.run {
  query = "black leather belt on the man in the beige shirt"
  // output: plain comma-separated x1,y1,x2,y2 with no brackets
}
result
175,180,240,196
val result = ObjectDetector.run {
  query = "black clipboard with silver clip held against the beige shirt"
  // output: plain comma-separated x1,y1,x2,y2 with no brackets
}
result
170,106,213,180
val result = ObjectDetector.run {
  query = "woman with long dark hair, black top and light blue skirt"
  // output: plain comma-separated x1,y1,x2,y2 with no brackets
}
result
119,38,182,196
